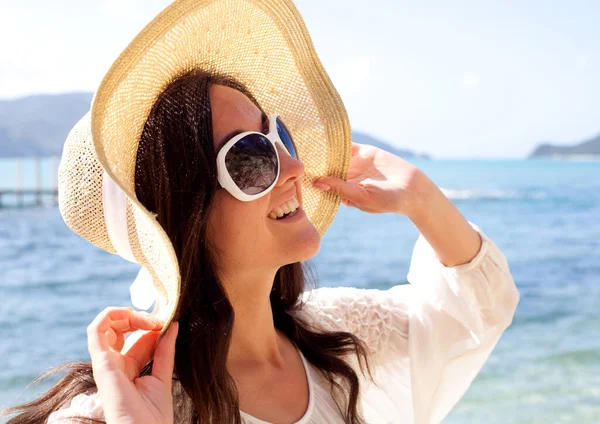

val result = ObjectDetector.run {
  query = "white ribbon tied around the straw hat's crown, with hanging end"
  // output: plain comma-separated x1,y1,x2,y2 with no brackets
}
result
102,171,157,310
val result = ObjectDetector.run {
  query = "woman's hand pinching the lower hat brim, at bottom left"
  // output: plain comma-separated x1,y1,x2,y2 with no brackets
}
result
87,308,178,424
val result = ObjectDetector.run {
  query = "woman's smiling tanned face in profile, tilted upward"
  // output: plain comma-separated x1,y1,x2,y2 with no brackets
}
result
208,84,321,281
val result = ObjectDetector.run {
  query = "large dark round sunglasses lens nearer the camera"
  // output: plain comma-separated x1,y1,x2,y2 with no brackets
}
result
225,134,277,195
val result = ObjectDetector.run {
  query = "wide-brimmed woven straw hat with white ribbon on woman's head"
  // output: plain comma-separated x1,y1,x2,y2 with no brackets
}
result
59,0,351,329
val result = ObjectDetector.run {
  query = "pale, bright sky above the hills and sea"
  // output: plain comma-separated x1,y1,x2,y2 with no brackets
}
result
0,0,600,158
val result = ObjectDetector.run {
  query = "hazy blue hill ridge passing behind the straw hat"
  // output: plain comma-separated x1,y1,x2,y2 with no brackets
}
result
0,93,429,158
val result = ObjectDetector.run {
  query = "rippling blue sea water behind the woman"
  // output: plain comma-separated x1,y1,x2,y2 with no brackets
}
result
0,160,600,424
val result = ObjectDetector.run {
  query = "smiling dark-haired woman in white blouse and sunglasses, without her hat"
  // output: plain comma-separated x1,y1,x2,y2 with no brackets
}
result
2,3,518,424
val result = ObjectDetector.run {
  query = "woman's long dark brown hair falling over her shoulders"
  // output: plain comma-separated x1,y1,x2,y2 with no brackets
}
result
5,71,369,424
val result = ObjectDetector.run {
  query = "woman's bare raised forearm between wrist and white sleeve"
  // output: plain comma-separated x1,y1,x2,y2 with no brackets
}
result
408,174,482,267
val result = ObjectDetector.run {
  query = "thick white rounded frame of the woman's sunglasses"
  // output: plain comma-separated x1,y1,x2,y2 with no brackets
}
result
217,113,295,202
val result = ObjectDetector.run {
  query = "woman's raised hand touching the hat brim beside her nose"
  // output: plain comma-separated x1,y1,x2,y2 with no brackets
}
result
315,143,435,217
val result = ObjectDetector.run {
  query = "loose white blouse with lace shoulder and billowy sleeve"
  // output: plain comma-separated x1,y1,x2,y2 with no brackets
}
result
48,224,519,424
